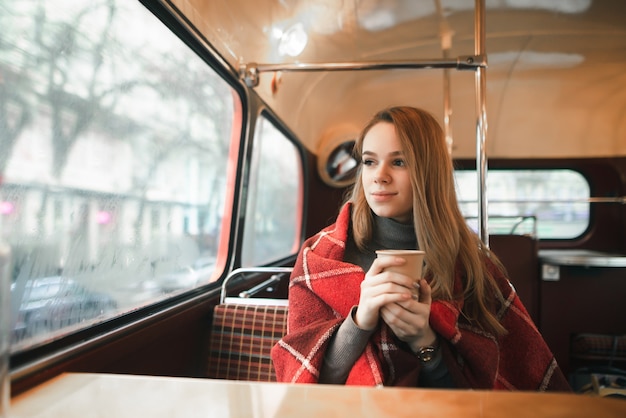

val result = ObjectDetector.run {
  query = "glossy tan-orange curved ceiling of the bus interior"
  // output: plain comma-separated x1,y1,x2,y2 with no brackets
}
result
172,0,626,158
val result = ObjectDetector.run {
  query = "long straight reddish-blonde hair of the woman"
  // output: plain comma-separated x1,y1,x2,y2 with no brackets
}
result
348,106,505,334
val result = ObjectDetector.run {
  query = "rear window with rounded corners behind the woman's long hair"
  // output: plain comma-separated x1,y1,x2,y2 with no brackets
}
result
455,169,590,239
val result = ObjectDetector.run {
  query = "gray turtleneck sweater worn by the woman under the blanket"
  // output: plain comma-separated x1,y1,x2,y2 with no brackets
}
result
319,215,453,387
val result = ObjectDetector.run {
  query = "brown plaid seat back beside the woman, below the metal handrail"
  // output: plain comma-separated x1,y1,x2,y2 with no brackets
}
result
208,304,287,382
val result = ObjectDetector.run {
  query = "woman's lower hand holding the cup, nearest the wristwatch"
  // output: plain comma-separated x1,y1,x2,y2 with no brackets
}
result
380,279,437,352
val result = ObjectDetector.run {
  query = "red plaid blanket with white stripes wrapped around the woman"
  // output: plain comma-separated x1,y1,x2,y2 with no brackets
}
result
271,205,570,391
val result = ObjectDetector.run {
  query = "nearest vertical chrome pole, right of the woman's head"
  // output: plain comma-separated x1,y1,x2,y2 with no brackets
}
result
474,0,489,247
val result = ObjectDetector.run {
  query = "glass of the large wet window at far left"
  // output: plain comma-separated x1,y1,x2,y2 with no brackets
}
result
0,0,240,351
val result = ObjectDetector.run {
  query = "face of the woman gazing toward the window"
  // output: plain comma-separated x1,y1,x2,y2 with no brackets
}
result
361,122,413,223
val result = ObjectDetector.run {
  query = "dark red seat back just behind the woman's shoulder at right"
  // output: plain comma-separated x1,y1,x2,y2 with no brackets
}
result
489,234,540,325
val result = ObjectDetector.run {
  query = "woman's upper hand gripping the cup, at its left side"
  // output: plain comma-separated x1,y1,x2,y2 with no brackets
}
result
354,257,415,331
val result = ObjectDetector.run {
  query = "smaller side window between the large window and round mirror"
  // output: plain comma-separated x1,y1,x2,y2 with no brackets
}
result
242,116,303,267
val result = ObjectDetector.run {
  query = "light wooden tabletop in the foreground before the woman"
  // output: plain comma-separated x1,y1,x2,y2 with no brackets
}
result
10,373,626,418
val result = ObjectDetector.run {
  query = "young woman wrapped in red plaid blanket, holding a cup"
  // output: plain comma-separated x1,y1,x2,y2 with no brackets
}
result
272,107,570,391
